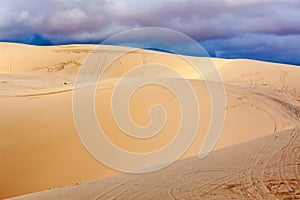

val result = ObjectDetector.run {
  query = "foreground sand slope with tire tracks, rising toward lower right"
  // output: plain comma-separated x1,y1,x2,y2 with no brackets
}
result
14,128,300,200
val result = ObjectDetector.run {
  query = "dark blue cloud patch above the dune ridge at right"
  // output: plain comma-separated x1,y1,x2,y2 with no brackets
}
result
201,34,300,65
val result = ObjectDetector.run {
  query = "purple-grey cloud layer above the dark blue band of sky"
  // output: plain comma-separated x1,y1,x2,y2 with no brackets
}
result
0,0,300,40
